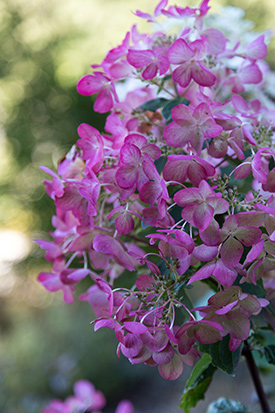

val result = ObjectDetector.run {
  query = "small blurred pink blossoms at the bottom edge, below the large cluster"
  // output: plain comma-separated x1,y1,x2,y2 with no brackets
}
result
42,380,134,413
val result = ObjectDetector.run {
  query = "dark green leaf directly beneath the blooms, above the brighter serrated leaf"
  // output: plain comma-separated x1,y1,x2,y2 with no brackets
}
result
200,334,241,376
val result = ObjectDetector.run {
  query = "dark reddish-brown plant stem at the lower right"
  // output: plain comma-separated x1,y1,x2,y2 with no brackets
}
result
243,341,272,413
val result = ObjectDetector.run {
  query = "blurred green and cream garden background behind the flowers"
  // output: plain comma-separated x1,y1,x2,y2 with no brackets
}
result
0,0,275,413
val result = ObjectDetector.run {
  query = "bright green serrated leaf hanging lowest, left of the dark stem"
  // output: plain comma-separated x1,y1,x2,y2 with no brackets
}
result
179,359,216,413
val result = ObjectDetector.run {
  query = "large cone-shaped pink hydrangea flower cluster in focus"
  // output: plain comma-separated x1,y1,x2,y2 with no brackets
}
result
37,0,275,380
